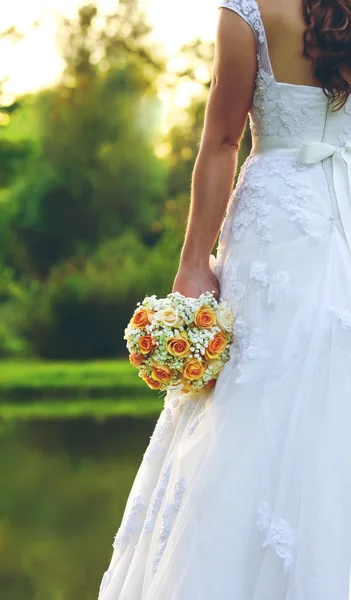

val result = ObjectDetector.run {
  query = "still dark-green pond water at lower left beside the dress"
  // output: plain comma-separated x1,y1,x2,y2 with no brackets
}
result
0,418,156,600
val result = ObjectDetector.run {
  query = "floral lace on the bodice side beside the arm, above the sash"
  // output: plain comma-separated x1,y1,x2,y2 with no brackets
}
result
250,59,315,137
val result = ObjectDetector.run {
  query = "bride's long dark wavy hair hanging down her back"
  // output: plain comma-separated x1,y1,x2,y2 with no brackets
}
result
302,0,351,111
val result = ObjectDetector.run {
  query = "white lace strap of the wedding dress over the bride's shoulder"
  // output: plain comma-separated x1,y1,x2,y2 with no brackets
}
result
218,0,274,77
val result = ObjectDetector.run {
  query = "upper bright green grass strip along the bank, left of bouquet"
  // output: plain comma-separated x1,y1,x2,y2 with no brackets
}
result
0,359,154,402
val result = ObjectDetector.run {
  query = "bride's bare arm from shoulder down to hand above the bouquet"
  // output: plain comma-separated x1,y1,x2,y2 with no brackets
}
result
173,8,257,297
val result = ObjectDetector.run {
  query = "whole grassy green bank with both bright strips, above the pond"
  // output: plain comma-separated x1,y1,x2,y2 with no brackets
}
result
0,359,163,420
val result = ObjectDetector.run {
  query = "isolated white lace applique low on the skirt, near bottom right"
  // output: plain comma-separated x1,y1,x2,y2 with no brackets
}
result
256,502,296,573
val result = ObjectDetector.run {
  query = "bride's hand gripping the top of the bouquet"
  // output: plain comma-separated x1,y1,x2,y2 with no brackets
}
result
172,263,220,300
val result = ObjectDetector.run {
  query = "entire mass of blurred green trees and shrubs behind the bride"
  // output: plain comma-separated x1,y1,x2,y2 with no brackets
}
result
0,0,253,359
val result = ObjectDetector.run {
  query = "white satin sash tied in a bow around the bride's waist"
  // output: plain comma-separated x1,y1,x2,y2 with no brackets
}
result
251,137,351,252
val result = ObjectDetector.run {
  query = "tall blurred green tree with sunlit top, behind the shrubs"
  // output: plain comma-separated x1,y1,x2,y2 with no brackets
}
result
8,0,165,277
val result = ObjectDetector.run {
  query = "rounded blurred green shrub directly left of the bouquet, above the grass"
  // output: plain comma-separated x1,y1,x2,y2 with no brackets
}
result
18,232,179,359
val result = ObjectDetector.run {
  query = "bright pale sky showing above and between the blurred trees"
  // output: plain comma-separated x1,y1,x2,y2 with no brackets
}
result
0,0,218,95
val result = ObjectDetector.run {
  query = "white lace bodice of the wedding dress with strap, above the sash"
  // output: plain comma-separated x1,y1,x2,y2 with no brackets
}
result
219,0,351,146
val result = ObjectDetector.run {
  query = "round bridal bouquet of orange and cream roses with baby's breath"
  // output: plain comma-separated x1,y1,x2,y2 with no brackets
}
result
124,292,234,394
